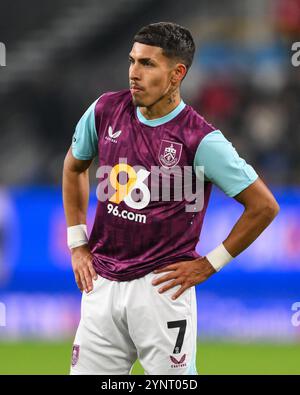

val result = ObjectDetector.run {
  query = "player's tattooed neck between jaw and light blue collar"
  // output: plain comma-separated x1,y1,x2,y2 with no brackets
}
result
139,90,181,119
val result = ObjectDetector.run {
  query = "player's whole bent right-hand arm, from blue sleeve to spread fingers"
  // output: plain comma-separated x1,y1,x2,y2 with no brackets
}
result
153,130,279,299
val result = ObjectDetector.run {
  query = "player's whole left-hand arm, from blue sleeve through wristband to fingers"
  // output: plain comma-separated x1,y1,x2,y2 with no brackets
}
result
63,99,99,292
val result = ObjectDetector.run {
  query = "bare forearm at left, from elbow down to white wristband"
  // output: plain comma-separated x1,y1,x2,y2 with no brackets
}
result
63,168,89,226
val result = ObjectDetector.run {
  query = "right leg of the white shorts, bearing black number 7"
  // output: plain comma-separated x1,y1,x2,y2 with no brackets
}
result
128,273,197,375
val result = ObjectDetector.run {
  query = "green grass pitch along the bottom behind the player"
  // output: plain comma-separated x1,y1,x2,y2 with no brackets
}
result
0,341,300,374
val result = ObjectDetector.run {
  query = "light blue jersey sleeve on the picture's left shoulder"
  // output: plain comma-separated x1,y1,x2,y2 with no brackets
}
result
72,99,98,160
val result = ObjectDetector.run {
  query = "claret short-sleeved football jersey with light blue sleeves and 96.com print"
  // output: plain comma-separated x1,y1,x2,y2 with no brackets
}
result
72,90,258,281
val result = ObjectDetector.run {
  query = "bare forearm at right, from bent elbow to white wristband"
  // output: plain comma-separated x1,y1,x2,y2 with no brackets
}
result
223,205,279,257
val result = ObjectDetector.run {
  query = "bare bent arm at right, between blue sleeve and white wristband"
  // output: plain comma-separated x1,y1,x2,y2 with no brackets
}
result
223,178,279,257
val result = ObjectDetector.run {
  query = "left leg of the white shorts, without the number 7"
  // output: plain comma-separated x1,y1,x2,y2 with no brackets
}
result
70,277,136,375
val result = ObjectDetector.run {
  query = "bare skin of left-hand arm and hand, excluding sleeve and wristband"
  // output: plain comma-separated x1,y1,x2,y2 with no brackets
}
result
63,148,97,292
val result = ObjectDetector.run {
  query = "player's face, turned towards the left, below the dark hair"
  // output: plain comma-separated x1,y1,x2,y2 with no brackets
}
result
129,42,174,107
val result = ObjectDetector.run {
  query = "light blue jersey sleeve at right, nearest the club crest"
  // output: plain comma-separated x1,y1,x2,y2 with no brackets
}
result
194,130,258,197
